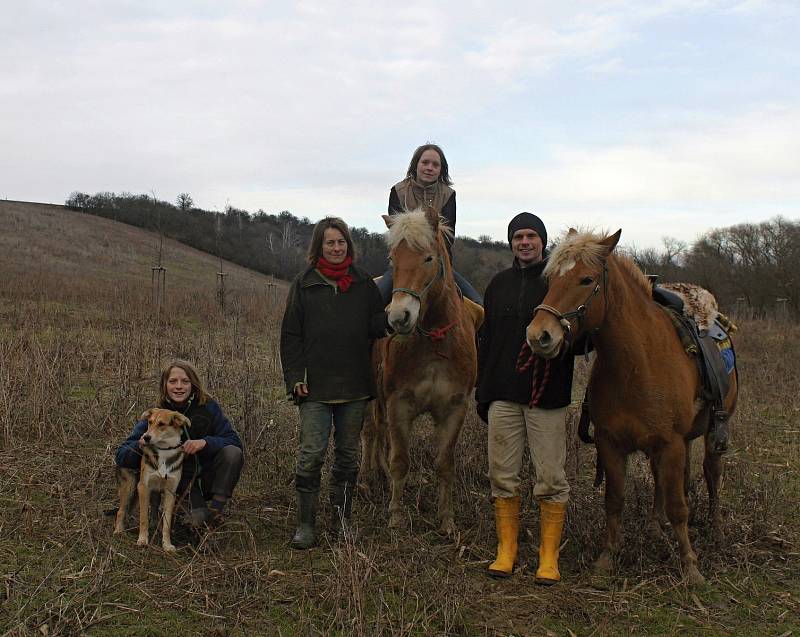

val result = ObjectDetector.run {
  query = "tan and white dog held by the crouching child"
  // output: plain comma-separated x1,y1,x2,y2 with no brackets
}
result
114,409,191,552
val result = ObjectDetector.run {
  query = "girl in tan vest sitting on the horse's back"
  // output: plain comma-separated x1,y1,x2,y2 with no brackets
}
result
378,144,483,305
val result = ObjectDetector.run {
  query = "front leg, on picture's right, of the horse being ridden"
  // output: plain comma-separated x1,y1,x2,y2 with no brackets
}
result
433,396,467,535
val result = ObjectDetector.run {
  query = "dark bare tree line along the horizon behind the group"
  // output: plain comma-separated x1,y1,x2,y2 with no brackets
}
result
66,192,800,319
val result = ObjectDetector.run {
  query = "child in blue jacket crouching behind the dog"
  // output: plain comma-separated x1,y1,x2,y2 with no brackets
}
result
114,360,244,525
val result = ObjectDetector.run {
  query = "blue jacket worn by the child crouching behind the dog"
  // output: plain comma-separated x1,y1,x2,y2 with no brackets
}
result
114,399,243,469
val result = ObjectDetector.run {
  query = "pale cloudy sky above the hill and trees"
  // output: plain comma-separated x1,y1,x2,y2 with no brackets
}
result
0,0,800,248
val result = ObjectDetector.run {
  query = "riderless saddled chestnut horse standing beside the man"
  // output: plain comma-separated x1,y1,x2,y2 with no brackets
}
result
527,230,738,584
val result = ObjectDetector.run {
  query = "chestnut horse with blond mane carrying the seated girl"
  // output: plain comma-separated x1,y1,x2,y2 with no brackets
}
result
365,207,479,533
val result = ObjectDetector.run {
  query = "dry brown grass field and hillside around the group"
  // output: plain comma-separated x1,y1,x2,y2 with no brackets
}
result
0,201,800,637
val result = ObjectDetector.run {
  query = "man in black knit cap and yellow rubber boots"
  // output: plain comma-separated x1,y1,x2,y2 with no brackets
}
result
476,212,573,585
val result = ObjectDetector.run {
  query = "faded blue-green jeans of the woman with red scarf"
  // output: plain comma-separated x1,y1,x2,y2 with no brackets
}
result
295,400,367,492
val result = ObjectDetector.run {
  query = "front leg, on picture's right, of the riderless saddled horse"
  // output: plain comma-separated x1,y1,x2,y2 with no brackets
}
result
657,436,705,585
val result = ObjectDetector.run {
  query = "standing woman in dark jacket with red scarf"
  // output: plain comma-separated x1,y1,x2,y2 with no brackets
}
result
281,217,386,549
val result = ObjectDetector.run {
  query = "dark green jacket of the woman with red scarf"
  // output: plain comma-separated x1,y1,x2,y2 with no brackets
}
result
281,265,387,402
